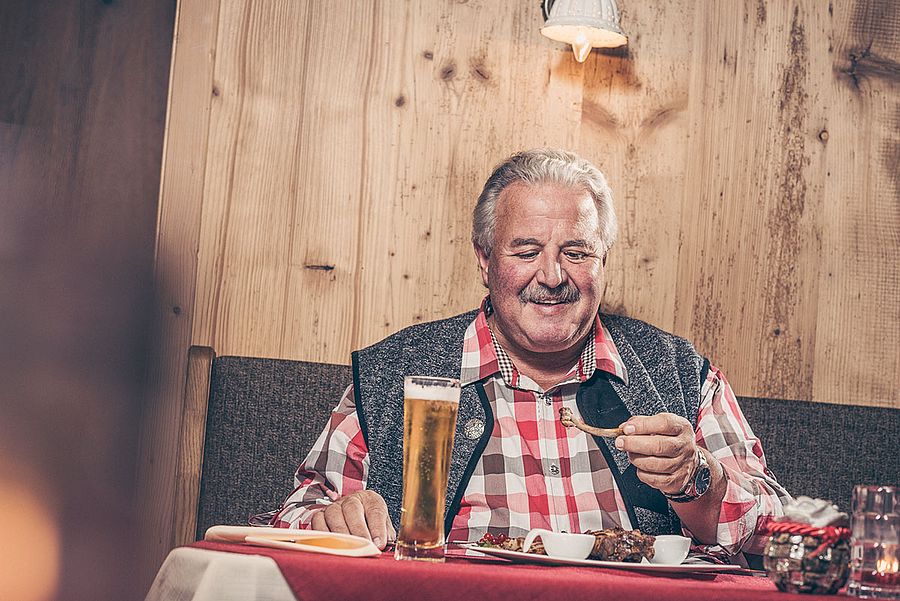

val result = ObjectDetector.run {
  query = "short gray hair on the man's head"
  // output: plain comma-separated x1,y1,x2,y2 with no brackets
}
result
472,148,618,256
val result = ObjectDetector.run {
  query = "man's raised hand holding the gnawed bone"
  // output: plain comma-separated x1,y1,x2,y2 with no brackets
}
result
616,413,697,494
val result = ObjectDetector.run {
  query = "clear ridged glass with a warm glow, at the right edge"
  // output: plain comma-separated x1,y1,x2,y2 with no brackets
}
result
847,486,900,599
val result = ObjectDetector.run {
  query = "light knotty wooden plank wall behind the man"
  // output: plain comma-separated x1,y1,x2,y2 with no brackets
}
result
146,0,900,584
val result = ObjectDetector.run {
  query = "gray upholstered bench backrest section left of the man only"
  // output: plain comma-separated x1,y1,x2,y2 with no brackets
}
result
197,357,352,539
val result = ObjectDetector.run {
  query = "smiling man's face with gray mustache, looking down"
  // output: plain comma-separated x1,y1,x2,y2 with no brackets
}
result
475,182,605,356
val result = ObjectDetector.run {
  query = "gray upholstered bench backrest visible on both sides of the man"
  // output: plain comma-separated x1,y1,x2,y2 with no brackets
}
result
197,357,900,538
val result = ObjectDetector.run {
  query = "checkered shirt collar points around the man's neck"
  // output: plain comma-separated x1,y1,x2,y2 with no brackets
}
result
460,296,628,387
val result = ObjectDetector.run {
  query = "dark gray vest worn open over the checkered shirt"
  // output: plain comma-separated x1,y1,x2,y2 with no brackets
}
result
352,310,708,534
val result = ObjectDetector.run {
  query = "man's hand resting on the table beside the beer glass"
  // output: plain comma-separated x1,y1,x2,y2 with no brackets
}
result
309,490,397,549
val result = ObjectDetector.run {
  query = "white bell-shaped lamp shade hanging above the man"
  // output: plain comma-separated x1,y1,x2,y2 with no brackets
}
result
541,0,628,63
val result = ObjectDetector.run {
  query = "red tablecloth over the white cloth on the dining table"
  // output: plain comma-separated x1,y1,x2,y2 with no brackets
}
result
193,541,852,601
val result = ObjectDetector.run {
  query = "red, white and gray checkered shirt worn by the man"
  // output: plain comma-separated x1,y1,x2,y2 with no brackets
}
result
272,306,789,554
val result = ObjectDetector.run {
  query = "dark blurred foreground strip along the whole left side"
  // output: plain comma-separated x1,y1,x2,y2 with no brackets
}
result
0,0,174,601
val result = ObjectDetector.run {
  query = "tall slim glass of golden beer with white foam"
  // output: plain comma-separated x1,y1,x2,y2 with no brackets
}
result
394,376,459,561
